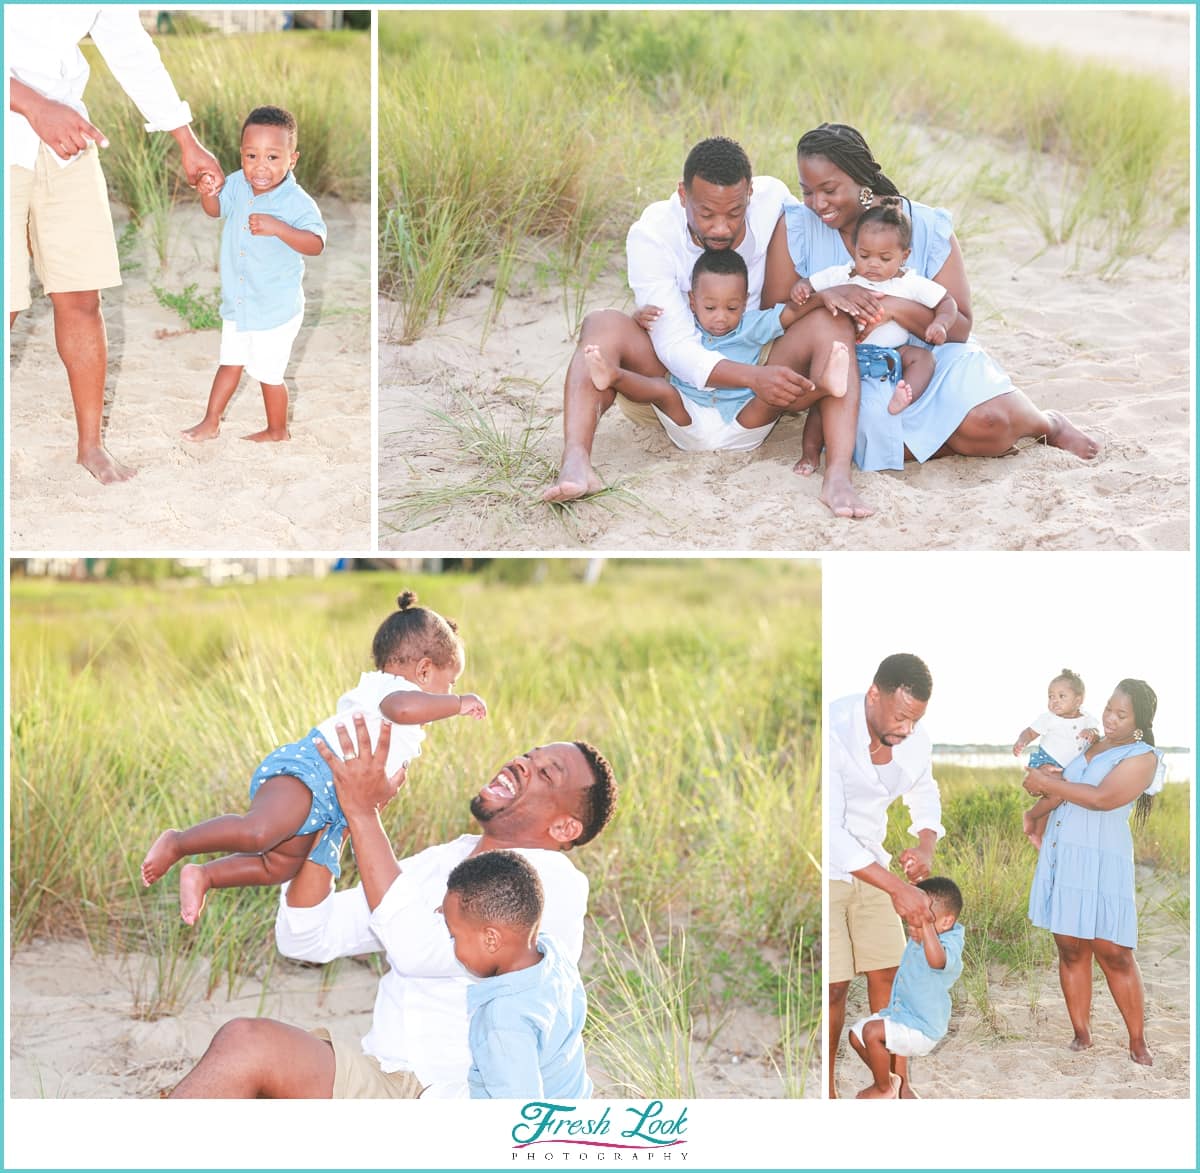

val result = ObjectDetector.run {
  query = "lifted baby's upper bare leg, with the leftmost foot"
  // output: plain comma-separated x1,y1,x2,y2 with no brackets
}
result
142,775,312,888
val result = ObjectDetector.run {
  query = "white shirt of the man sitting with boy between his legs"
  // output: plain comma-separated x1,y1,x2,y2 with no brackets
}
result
625,175,796,387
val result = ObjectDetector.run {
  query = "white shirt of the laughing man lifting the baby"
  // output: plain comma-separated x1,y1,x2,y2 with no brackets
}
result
275,835,588,1097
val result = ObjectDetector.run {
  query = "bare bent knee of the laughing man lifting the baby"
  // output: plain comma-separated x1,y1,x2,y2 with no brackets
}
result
170,1018,335,1100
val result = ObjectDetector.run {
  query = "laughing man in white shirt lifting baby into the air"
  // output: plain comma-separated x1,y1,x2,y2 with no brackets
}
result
173,715,617,1099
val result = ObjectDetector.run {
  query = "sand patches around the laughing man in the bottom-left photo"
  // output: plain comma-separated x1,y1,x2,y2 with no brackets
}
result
8,939,806,1099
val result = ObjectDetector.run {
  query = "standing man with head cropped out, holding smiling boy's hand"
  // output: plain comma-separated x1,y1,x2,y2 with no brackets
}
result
5,5,224,485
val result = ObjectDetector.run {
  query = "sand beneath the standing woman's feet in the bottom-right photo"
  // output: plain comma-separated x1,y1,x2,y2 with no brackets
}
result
838,868,1192,1100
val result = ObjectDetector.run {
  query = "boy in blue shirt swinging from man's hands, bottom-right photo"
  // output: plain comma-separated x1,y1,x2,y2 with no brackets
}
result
850,876,964,1100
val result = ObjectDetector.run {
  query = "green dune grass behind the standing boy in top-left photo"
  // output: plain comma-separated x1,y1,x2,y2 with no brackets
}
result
84,30,371,263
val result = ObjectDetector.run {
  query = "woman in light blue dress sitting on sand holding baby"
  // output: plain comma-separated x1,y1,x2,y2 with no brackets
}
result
763,122,1099,475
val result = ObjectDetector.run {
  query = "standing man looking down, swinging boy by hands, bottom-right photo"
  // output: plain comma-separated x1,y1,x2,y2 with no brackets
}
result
827,652,946,1099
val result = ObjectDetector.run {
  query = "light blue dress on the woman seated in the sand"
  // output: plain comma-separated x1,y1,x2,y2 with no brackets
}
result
784,203,1014,473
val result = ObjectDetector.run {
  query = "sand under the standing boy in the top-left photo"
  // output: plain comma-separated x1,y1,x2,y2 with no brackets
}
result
8,200,371,554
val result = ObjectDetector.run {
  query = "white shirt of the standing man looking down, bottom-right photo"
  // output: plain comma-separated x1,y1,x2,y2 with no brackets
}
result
827,693,946,880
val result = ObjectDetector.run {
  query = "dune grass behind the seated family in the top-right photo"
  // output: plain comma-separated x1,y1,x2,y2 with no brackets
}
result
379,10,1190,342
